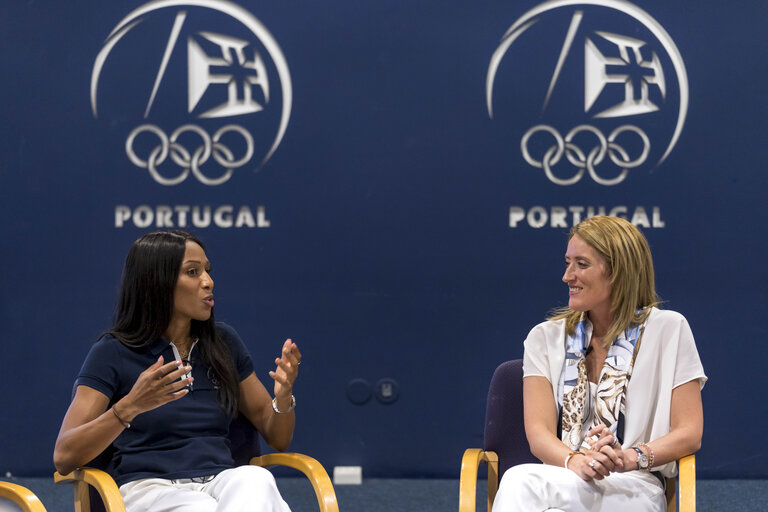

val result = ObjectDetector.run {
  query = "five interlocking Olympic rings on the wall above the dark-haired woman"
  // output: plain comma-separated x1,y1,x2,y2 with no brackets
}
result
125,124,253,186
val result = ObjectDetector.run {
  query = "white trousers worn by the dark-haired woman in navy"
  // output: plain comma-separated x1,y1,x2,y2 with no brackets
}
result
120,466,291,512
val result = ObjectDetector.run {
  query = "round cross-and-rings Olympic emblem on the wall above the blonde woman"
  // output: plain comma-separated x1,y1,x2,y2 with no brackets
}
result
486,0,688,186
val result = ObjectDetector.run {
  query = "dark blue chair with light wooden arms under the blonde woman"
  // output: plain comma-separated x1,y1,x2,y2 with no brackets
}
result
459,359,696,512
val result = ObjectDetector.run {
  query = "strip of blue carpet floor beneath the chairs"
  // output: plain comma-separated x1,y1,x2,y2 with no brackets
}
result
0,477,768,512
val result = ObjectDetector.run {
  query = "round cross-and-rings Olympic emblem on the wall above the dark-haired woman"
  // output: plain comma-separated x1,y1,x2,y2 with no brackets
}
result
91,0,293,186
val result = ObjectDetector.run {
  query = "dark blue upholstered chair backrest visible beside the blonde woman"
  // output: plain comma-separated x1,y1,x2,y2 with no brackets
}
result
483,359,539,479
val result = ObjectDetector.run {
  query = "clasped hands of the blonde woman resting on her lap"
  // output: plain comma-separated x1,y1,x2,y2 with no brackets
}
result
568,424,637,481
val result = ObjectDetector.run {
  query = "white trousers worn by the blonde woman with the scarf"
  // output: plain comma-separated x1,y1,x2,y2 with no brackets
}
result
493,464,667,512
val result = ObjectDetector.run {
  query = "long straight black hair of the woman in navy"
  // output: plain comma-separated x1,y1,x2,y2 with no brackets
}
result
105,230,239,417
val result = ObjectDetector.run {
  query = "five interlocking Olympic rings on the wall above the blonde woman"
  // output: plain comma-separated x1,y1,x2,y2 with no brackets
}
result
520,124,651,186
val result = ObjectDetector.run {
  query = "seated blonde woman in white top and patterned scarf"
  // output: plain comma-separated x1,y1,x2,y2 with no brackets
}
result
493,216,707,512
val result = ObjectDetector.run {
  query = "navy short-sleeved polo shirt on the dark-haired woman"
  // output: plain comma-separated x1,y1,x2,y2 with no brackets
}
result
77,323,253,486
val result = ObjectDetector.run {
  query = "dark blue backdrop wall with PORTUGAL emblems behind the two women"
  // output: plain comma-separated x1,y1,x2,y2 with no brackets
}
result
0,0,768,478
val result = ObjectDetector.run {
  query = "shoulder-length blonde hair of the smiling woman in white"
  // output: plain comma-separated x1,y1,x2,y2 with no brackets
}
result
548,216,659,346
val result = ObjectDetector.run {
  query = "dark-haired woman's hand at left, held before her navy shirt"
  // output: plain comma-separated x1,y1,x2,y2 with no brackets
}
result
120,356,194,423
